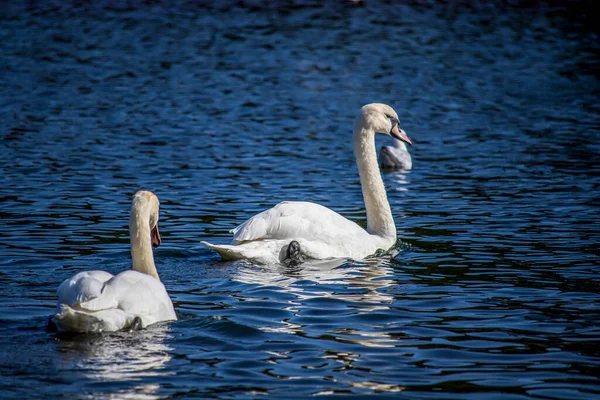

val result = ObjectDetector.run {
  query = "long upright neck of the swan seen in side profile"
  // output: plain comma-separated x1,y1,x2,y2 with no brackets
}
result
354,116,396,240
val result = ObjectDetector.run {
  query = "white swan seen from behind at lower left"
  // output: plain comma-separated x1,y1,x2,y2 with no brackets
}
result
52,190,177,332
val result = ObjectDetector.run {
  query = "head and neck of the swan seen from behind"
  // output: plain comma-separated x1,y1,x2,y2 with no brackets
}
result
129,190,161,279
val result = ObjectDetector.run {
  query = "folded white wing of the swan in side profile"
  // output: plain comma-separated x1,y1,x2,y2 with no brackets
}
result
232,201,366,244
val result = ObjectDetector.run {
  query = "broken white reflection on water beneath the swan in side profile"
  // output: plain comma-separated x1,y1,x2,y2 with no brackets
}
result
232,250,404,395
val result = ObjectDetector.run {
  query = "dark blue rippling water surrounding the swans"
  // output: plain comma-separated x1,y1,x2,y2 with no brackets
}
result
0,0,600,399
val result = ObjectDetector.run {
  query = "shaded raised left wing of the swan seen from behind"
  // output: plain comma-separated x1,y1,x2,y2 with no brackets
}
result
58,271,113,307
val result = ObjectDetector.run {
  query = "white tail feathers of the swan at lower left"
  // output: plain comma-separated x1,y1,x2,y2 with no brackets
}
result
52,304,133,332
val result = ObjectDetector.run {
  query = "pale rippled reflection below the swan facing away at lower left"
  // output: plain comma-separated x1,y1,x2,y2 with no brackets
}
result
57,323,174,399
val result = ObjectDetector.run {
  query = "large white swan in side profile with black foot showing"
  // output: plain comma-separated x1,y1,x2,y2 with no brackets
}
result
202,103,411,264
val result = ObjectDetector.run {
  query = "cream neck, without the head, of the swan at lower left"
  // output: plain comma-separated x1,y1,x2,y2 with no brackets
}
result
129,207,160,280
